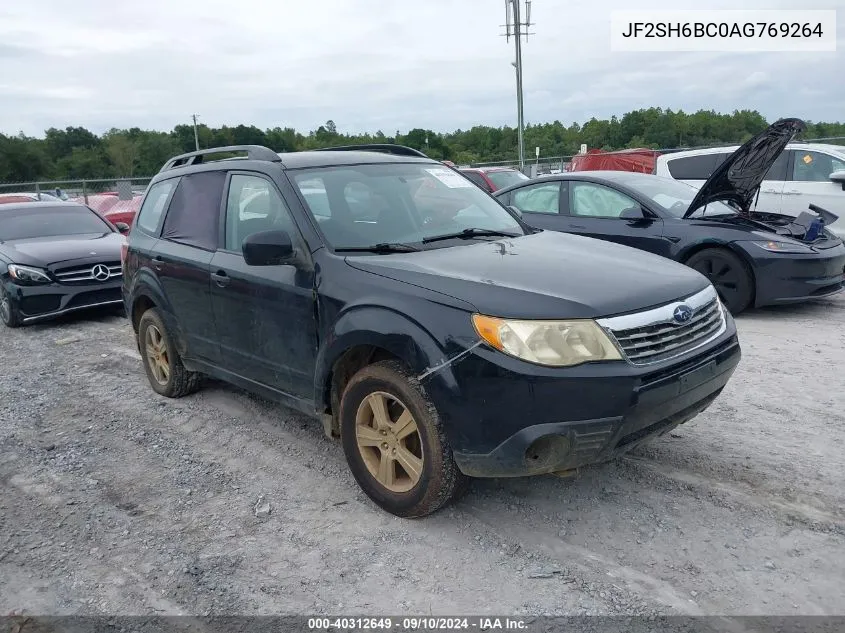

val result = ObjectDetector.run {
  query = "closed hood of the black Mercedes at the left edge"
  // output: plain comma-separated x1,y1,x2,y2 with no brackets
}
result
0,233,124,267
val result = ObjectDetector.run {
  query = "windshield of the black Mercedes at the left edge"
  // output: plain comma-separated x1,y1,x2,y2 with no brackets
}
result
0,205,111,242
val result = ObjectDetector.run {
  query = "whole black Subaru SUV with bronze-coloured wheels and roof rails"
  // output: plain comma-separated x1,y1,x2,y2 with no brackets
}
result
123,146,740,517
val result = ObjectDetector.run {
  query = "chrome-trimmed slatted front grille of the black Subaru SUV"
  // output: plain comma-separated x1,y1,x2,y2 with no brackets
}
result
599,286,726,365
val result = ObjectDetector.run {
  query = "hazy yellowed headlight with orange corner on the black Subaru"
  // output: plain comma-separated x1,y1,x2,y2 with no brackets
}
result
472,314,622,367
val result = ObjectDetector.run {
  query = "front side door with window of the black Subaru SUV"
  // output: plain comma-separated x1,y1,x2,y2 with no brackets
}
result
210,172,317,399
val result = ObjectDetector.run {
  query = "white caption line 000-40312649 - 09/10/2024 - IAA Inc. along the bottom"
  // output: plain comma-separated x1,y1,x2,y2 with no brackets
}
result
308,616,527,631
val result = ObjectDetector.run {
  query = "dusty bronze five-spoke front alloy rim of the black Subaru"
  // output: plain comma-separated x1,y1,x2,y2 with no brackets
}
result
355,391,424,493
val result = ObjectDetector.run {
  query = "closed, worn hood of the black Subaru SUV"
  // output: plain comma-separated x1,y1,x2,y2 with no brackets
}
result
346,231,709,319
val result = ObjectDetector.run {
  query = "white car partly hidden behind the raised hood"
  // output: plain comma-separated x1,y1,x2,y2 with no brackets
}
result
655,143,845,236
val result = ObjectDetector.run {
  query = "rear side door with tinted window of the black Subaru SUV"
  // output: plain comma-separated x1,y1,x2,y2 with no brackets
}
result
152,171,226,364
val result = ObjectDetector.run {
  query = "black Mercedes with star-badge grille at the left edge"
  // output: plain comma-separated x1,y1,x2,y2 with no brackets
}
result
0,201,125,327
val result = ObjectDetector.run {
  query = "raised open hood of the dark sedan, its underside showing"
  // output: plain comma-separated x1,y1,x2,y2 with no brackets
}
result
684,119,806,218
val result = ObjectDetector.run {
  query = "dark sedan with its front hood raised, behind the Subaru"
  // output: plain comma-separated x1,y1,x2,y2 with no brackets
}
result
494,119,845,314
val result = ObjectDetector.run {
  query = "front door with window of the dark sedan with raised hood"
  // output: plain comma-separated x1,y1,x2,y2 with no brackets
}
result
566,181,668,256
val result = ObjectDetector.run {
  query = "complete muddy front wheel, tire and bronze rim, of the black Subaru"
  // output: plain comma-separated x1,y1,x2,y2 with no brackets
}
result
340,360,469,518
